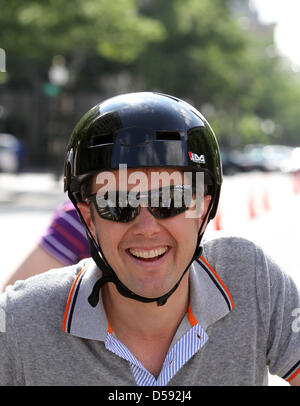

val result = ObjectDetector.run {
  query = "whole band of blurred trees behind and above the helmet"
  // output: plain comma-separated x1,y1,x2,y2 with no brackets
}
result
0,0,300,171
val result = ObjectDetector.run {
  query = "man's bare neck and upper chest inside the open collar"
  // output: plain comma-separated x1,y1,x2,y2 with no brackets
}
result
102,274,189,378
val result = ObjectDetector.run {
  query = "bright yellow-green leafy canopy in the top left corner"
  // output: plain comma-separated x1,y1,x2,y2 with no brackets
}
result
0,0,164,62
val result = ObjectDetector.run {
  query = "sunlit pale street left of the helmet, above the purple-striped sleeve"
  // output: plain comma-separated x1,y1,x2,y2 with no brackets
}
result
0,173,66,286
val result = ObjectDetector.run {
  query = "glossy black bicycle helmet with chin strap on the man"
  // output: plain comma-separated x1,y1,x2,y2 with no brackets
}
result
64,92,222,306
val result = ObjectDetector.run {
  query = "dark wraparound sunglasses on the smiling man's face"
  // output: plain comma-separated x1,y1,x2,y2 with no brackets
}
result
87,185,195,223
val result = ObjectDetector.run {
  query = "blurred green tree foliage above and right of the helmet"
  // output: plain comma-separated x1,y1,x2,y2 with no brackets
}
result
137,0,300,147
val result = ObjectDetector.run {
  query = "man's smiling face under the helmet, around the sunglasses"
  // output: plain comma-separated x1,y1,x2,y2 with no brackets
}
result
79,169,210,298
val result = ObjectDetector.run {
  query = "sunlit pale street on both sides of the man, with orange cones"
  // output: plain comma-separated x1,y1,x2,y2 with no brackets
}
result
0,172,300,385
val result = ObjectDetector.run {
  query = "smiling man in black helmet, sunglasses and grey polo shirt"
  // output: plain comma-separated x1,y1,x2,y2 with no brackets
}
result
0,93,300,386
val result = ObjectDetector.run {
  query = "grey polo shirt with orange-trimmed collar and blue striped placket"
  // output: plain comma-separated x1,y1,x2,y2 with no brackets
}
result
0,233,300,386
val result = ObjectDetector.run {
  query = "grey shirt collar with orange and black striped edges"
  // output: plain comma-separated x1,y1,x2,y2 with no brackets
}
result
63,257,233,341
